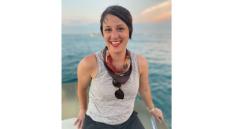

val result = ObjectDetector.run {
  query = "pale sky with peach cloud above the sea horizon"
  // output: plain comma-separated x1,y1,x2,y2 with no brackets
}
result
62,0,171,26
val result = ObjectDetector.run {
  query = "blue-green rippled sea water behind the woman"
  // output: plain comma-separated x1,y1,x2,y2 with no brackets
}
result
62,22,171,129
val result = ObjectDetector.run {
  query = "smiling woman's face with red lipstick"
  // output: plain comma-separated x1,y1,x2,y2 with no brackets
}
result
102,14,129,53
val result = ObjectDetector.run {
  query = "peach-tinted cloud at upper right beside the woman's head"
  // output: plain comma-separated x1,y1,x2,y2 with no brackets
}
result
134,1,171,23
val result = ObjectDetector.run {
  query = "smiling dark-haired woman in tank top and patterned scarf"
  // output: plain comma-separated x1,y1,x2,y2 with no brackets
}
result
75,5,163,129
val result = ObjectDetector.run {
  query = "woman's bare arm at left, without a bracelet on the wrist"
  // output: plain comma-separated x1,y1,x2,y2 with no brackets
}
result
75,55,97,129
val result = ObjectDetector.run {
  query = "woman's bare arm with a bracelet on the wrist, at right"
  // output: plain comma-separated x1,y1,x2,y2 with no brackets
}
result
138,56,163,121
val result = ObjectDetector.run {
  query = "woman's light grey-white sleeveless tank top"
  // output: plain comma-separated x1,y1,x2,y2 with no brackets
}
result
86,51,139,125
